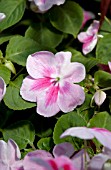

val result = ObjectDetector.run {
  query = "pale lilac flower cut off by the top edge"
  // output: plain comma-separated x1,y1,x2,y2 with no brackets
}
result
29,0,65,12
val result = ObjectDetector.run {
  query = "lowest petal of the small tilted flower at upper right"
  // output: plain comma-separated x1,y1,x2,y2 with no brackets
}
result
82,35,98,55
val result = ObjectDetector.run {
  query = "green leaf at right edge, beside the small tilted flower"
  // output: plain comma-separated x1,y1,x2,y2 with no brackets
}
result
96,34,111,64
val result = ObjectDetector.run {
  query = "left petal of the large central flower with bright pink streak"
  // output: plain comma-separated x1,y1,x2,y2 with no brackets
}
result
20,76,51,102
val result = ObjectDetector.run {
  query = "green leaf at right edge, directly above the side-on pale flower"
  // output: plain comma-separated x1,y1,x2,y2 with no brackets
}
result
88,112,111,131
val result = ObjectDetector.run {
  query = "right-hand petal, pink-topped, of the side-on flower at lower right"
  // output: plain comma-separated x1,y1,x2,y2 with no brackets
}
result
90,128,111,149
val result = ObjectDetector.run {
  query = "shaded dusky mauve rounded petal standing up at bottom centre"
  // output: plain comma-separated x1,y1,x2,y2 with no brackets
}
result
53,142,74,158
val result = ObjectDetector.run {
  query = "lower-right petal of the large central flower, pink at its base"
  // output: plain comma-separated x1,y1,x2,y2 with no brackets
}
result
58,81,85,113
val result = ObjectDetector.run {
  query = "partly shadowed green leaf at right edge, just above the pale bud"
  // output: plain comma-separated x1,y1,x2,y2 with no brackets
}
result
94,70,111,87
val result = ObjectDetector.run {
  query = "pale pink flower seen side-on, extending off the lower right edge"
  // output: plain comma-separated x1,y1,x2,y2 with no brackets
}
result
61,127,111,149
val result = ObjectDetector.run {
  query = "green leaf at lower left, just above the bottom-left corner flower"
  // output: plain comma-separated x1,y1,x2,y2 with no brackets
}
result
3,120,35,149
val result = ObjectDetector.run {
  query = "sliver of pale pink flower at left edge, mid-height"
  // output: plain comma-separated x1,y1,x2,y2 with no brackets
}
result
0,77,6,101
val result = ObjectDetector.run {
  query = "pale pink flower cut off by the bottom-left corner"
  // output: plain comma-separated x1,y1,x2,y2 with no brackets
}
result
0,139,21,170
